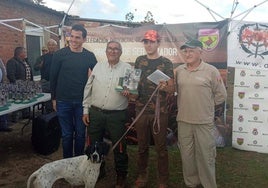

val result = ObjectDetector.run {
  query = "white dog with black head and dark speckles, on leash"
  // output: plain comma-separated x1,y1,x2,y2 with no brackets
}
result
27,142,110,188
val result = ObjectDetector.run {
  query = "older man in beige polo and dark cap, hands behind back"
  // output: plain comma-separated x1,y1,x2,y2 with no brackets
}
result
175,39,227,188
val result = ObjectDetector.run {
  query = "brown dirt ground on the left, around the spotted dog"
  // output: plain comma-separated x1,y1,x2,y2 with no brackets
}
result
0,120,118,188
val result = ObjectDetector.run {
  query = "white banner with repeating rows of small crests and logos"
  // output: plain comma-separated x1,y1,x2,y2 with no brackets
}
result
232,68,268,153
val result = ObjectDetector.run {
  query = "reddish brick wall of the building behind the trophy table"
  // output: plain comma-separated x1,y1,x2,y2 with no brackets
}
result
0,0,64,63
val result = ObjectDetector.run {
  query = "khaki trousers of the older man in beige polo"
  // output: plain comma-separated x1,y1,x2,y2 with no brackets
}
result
178,121,217,188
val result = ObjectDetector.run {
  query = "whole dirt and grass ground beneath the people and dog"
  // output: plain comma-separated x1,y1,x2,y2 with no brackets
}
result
0,119,268,188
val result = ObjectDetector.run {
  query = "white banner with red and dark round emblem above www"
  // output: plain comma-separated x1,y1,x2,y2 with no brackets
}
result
228,21,268,70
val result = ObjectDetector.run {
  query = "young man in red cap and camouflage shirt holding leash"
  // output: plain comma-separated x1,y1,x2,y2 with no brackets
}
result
135,30,174,188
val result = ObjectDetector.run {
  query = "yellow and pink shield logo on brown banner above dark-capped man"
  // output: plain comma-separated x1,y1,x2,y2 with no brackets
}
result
198,29,220,51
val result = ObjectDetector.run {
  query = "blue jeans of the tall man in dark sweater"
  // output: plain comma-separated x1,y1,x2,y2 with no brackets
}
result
57,101,86,158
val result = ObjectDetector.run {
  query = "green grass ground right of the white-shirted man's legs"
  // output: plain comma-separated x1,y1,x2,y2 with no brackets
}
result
125,146,268,188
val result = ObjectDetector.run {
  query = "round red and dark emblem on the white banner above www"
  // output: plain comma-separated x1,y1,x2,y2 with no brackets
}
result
239,23,268,59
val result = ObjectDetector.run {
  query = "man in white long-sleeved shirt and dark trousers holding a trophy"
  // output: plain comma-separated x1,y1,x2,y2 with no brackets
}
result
83,41,131,188
